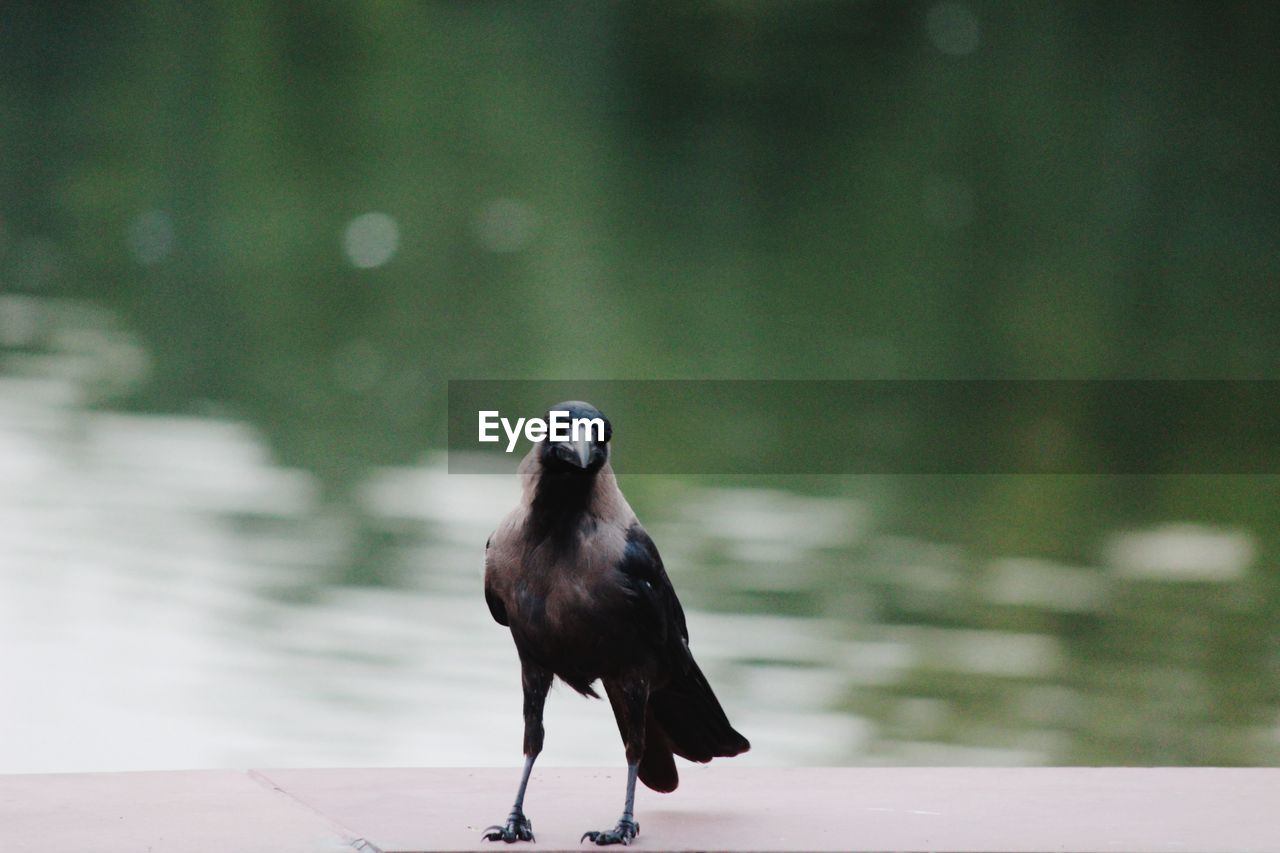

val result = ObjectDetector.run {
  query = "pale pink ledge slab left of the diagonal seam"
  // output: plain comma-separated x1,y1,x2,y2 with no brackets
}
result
0,770,355,853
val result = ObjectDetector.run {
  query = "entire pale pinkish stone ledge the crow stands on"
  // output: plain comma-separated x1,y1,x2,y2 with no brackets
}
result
0,762,1280,853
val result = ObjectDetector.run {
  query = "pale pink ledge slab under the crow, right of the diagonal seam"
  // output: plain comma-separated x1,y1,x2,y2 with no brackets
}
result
262,762,1280,853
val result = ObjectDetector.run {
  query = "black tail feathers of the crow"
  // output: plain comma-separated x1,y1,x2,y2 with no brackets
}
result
640,661,751,793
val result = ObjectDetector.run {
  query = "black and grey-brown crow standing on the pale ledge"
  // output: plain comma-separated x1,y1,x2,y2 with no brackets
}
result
481,401,750,845
